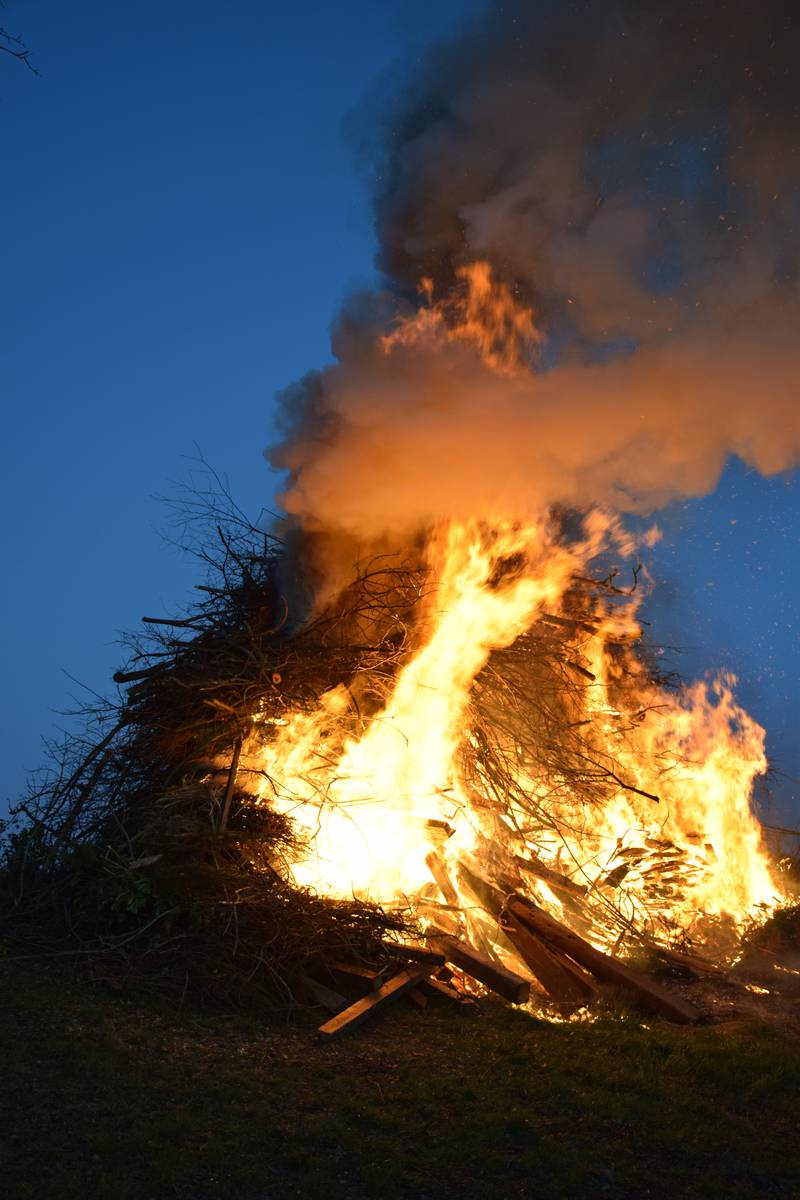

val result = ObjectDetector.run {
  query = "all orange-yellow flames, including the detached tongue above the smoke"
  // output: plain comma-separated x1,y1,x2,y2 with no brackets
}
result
248,263,778,965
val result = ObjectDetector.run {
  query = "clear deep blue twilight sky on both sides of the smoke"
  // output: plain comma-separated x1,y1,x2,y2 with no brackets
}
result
0,0,800,824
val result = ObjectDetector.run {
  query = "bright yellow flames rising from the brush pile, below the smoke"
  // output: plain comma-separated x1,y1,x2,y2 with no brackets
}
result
251,515,776,931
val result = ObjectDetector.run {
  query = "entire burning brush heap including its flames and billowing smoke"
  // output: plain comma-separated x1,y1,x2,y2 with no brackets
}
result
2,2,800,1034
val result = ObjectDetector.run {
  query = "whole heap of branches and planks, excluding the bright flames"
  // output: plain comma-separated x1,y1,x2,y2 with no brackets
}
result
0,482,796,1027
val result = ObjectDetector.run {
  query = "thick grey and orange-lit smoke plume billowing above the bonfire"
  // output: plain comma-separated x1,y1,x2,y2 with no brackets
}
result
271,0,800,539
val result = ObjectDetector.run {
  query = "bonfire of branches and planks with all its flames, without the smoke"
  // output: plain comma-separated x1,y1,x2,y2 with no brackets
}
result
4,263,796,1036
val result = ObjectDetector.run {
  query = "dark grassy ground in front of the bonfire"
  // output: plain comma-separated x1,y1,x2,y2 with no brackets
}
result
0,962,800,1200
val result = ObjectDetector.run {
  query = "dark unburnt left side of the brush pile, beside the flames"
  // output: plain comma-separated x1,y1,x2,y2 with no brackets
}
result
0,496,405,1013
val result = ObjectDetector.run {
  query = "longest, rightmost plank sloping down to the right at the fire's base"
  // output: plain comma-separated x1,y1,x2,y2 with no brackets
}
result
507,894,699,1025
